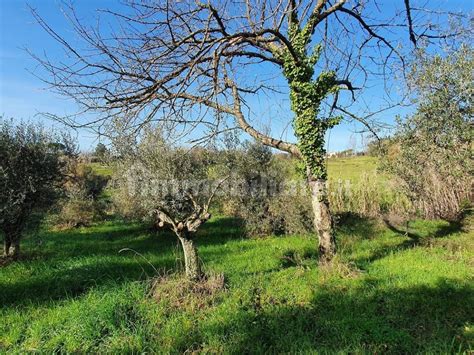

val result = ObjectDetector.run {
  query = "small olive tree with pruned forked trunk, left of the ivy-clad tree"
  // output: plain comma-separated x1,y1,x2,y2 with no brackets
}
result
112,126,225,279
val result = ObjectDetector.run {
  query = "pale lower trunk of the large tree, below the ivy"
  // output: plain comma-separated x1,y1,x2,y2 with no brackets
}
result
308,175,336,263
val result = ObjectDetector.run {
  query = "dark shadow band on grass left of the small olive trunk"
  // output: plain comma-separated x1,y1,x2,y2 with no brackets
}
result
0,225,181,307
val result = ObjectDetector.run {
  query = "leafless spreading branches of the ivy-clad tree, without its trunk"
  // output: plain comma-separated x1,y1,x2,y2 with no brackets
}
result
30,0,465,149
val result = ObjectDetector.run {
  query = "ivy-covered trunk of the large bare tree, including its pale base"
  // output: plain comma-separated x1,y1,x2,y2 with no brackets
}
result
274,19,341,263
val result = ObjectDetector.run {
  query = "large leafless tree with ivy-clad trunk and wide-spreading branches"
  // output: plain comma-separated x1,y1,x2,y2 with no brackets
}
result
32,0,470,262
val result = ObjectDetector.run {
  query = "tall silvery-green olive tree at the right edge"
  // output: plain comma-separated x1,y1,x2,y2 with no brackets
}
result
384,45,474,220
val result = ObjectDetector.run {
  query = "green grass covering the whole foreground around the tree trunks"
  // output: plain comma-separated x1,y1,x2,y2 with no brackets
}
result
0,216,474,353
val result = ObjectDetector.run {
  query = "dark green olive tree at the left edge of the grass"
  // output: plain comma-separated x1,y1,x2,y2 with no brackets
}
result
0,118,75,258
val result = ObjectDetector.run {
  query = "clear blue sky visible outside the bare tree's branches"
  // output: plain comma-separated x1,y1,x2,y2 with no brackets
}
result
0,0,474,151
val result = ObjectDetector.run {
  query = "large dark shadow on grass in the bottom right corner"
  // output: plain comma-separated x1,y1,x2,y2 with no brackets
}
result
198,280,474,353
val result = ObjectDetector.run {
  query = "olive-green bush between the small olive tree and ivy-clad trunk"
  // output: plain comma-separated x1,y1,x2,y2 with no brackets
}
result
223,142,312,237
